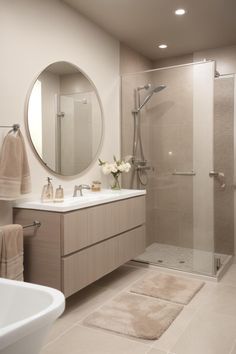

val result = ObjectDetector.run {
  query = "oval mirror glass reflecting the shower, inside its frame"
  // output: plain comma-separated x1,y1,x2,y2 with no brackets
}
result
27,62,103,176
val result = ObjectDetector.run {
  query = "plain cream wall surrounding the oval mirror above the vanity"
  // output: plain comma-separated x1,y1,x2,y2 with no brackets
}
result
0,0,120,224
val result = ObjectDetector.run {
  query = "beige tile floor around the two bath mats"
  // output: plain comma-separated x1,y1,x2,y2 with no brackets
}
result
41,264,236,354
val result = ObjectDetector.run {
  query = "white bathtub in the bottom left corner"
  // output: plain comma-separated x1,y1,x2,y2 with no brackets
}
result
0,278,65,354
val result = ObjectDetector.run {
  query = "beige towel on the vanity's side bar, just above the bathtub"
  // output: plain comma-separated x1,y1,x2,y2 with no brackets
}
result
0,224,24,280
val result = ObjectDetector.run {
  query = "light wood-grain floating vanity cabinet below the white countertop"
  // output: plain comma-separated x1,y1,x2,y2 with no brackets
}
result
14,195,145,297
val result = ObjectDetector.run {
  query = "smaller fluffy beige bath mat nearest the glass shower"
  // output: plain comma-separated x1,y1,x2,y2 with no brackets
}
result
130,273,204,305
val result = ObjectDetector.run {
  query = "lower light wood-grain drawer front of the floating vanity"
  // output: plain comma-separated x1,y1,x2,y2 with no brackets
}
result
62,226,145,297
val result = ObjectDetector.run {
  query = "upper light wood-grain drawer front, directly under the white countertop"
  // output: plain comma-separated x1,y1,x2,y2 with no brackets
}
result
62,196,145,255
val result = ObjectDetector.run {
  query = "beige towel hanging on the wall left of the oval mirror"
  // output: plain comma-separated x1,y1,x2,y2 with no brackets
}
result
0,130,31,199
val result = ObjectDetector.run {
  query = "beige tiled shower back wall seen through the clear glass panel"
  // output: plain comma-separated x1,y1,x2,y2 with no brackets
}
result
149,66,193,247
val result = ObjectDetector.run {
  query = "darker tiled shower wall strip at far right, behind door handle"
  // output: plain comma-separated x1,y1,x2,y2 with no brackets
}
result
214,75,234,254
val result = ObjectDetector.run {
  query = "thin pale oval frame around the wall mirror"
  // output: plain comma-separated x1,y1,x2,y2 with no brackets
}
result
24,60,105,179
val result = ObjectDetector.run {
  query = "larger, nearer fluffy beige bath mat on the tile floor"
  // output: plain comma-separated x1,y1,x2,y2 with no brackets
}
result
84,293,183,339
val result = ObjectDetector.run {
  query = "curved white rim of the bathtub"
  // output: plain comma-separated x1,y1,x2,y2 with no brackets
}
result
0,278,65,350
